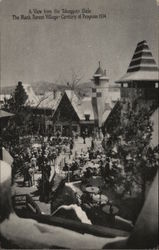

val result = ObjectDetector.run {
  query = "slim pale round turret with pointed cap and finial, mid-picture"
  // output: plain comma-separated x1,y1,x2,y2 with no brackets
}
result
92,62,109,127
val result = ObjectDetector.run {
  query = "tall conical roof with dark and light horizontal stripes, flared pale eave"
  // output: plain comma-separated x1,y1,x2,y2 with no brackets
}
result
116,40,159,83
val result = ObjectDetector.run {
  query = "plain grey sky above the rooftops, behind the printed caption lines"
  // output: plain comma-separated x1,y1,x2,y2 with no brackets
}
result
0,0,158,86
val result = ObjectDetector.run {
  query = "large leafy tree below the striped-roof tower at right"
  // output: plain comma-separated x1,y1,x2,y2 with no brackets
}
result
103,99,157,200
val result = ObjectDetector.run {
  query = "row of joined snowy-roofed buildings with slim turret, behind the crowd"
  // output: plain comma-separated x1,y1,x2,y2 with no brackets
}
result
12,62,120,136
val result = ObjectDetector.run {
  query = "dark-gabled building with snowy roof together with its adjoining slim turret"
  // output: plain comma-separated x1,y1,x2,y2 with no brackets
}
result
53,62,120,136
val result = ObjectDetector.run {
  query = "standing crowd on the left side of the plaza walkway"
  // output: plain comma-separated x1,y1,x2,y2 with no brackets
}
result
11,133,74,200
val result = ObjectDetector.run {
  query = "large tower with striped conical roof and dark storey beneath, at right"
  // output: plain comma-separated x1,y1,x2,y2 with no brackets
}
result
116,40,159,104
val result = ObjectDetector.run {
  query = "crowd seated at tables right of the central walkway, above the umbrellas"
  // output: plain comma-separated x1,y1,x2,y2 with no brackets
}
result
63,139,120,186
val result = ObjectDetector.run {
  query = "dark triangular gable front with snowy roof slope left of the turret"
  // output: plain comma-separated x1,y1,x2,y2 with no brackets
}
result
53,90,94,136
